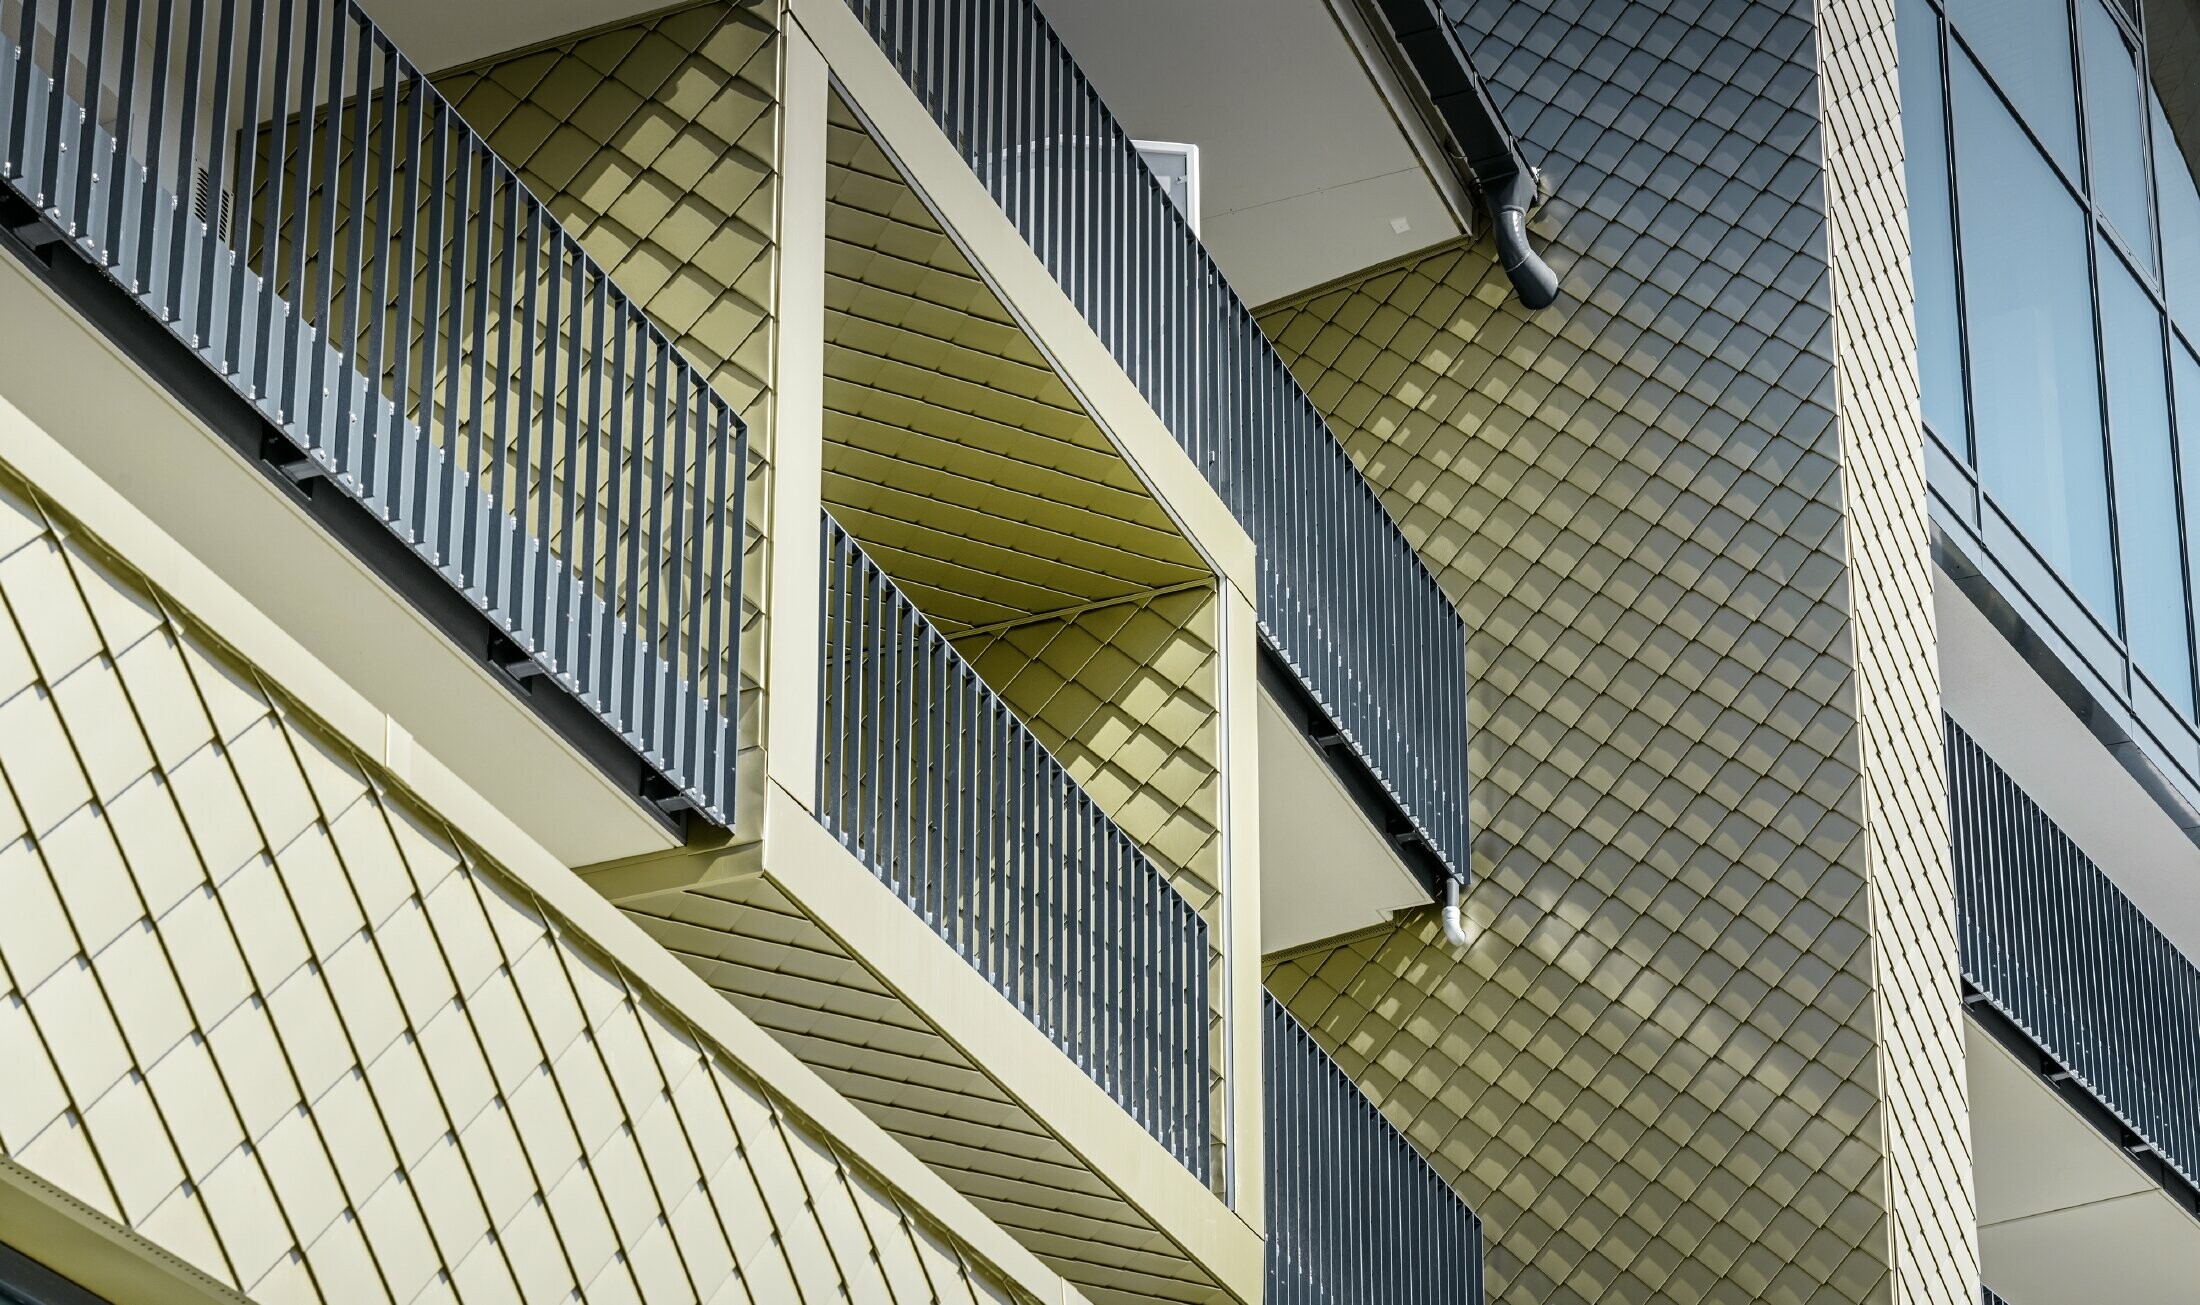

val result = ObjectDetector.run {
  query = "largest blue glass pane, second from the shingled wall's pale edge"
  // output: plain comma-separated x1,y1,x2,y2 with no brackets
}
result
1954,59,2116,623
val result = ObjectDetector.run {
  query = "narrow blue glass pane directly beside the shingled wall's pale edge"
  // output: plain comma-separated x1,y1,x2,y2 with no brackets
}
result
1894,0,1971,458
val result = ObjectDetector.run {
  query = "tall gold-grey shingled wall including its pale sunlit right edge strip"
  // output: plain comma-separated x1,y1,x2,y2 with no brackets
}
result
1263,0,1976,1303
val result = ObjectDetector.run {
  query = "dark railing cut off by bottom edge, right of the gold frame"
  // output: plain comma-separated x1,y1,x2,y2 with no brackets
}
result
1261,993,1483,1305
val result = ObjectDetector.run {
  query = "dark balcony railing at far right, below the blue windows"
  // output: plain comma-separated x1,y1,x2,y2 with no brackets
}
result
1945,720,2200,1186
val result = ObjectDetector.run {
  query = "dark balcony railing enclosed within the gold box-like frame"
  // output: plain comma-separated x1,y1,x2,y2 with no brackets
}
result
818,515,1212,1182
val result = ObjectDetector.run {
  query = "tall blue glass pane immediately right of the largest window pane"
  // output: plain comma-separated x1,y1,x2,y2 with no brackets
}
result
2099,234,2193,715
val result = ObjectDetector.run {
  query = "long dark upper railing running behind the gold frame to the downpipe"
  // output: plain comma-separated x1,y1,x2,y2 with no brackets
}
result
849,0,1467,876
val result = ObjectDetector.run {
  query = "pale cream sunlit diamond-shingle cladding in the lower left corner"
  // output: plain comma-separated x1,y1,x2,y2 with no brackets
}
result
0,473,1014,1305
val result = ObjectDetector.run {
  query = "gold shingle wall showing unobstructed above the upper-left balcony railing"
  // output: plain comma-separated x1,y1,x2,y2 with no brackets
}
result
436,0,779,805
